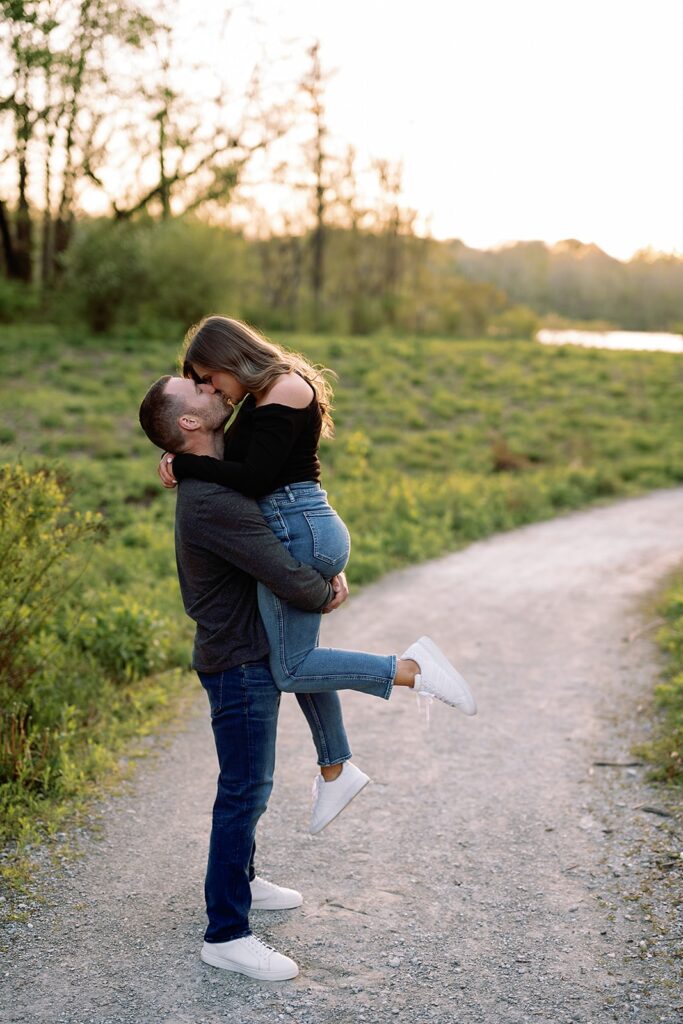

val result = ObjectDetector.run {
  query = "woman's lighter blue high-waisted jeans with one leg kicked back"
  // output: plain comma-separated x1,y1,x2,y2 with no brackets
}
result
258,482,396,765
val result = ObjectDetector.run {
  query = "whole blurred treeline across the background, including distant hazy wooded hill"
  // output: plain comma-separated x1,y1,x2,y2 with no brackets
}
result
5,212,683,338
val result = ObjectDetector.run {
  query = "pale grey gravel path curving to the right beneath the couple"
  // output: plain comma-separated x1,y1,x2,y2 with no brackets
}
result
0,488,683,1024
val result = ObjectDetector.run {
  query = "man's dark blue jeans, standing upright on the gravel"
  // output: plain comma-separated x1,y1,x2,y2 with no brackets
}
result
198,659,280,942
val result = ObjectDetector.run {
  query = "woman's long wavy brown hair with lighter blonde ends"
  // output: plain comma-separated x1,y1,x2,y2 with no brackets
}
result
182,315,334,437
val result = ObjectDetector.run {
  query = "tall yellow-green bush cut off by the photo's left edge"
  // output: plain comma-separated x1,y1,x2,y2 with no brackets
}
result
0,465,102,808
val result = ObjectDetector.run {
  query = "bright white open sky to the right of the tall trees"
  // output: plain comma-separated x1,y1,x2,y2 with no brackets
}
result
180,0,683,258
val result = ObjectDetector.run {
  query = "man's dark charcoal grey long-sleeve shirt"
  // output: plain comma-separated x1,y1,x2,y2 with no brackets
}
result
175,477,334,673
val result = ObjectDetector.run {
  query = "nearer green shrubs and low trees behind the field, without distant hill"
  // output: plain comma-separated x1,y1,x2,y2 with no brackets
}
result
0,218,538,337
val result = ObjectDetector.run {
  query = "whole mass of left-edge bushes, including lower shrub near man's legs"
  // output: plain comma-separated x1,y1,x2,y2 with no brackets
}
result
0,465,177,838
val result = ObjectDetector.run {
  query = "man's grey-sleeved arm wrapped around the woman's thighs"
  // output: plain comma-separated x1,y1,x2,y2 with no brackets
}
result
193,484,335,611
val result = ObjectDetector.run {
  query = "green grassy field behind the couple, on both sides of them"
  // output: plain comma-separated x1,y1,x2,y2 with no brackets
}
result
0,328,683,872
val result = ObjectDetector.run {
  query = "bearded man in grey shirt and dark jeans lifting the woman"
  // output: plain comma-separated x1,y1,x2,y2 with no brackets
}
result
140,377,348,981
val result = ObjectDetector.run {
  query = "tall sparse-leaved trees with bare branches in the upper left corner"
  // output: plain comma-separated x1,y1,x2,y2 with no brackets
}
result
0,0,287,288
